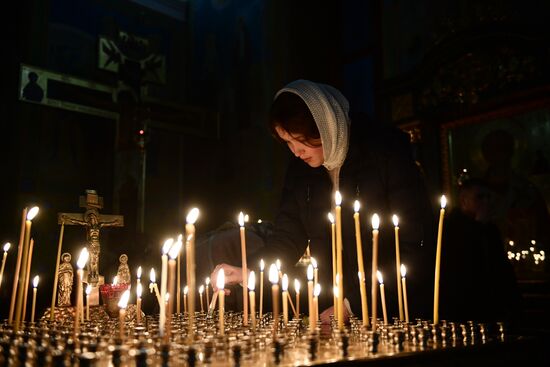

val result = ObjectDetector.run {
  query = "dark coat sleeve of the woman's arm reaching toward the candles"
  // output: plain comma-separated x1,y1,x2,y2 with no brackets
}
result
248,162,307,267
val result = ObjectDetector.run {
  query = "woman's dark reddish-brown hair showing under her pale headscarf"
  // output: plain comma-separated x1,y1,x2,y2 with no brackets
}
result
269,92,321,146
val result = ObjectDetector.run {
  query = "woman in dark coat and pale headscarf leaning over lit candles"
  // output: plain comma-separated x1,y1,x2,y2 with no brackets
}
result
212,80,435,321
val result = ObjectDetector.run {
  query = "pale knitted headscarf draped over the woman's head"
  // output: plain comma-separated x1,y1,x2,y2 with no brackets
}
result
275,79,350,190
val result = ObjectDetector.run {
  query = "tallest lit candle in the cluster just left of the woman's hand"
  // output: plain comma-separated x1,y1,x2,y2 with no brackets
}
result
185,208,199,340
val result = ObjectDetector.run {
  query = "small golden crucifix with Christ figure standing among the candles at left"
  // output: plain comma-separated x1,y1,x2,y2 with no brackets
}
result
57,190,124,288
